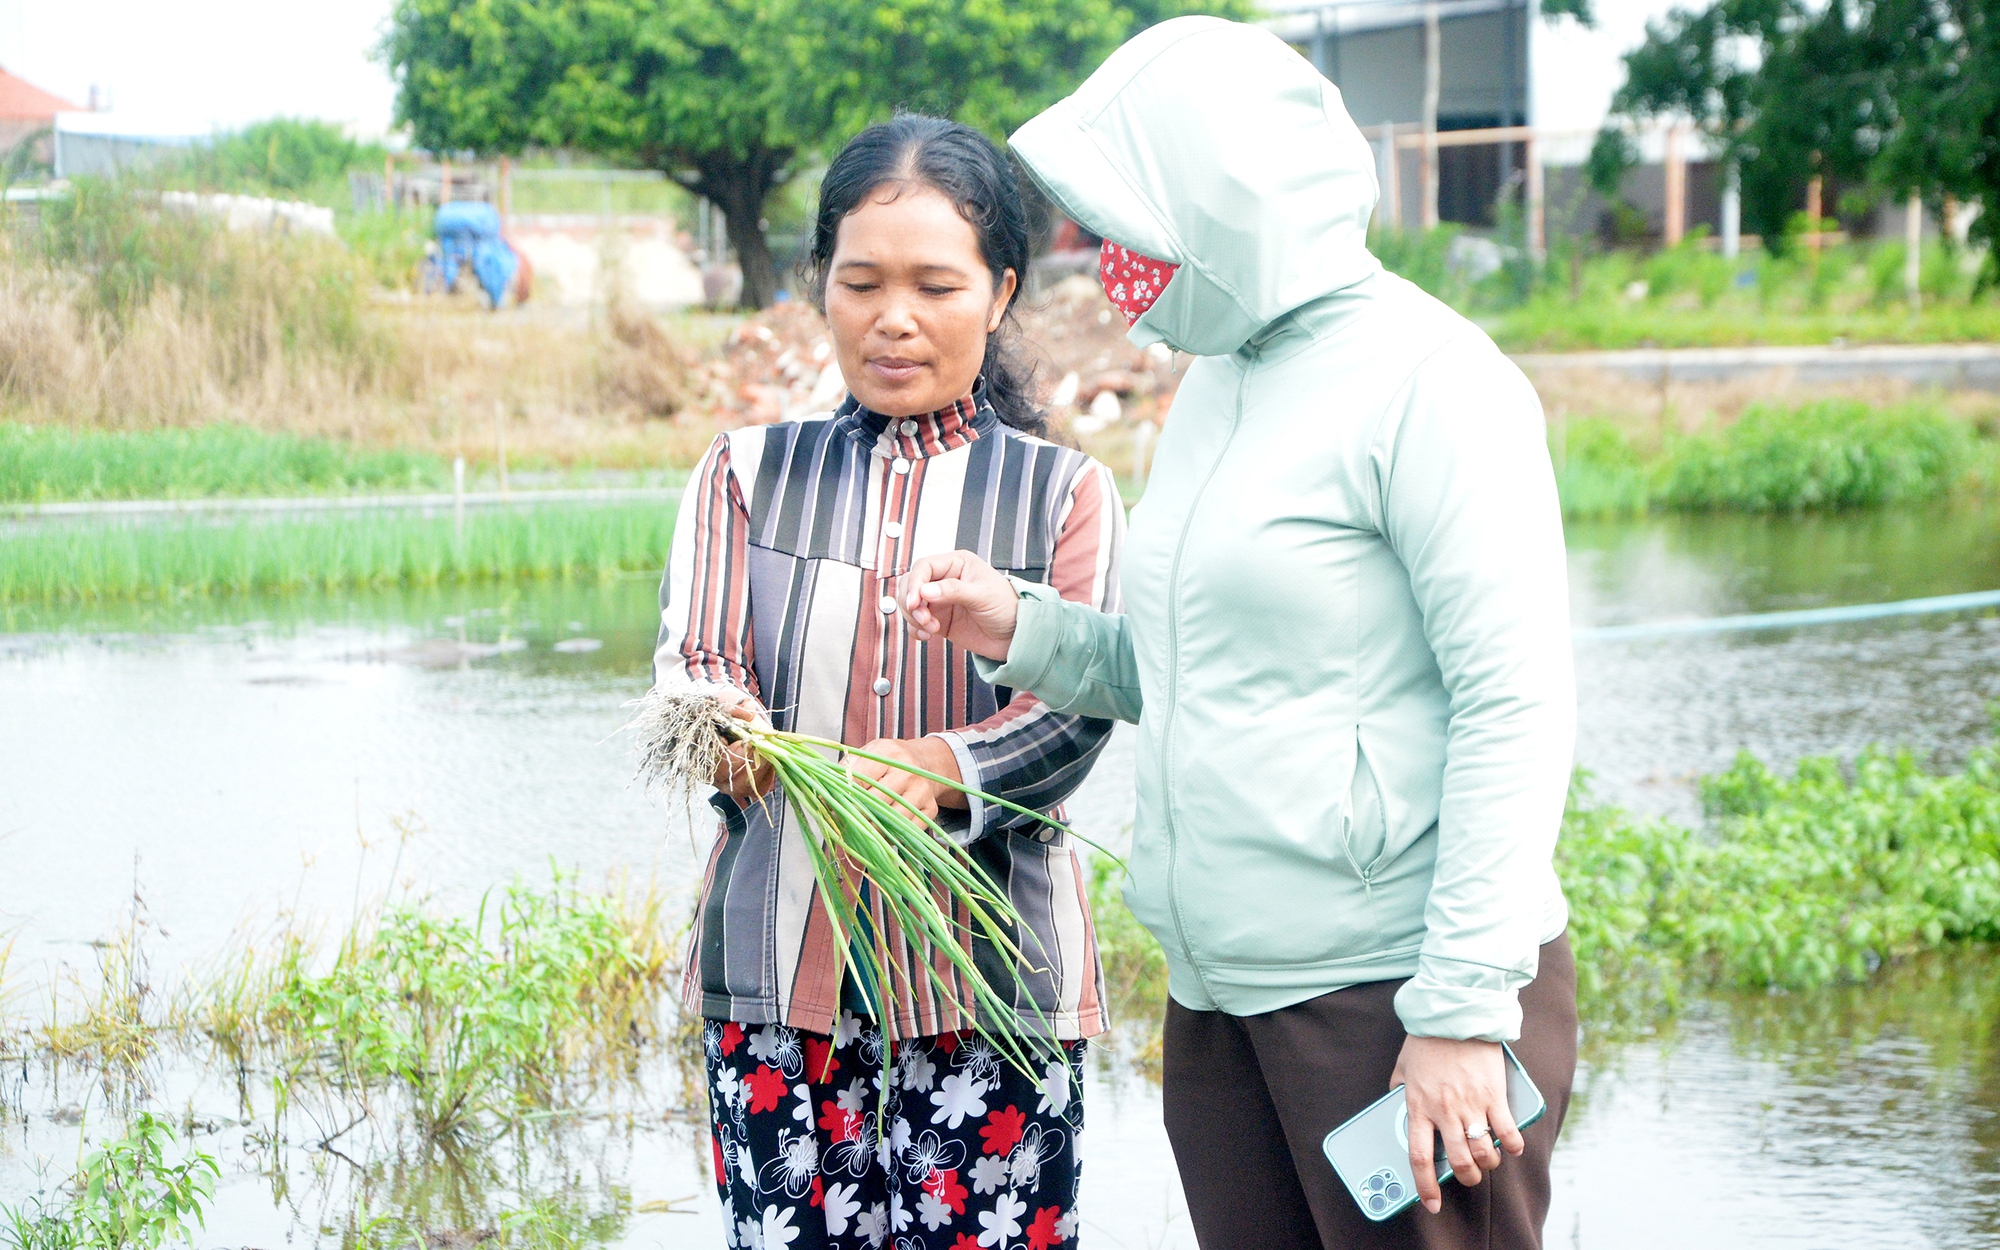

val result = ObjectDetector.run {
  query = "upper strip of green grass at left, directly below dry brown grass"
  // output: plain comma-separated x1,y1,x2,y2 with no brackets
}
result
0,422,450,504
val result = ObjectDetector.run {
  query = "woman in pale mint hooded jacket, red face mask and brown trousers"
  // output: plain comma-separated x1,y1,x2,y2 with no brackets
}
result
898,18,1576,1250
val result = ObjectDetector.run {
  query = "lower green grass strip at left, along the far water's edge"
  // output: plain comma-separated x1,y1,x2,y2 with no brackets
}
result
0,504,674,604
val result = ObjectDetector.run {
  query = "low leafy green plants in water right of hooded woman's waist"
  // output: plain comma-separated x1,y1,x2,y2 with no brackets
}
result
1090,720,2000,1026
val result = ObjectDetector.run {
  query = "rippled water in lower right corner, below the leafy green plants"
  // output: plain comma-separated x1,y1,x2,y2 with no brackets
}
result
1548,950,2000,1250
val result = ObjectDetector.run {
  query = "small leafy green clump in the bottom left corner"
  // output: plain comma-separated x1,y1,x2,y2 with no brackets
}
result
0,1112,218,1250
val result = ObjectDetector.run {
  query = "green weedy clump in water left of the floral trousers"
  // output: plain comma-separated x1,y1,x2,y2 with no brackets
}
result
196,878,672,1140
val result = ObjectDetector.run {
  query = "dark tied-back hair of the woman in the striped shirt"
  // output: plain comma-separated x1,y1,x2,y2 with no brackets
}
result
806,112,1048,434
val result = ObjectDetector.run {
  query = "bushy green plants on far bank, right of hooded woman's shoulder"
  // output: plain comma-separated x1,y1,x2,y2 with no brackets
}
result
1550,400,1996,516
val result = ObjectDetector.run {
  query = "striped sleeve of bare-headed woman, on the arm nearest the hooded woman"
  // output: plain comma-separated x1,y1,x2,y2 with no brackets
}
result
936,460,1124,842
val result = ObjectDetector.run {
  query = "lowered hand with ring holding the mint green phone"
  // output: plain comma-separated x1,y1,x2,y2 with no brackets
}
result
1390,1038,1526,1214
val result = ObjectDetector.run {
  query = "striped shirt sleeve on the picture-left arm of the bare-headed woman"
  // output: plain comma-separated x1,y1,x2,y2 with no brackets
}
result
652,434,762,698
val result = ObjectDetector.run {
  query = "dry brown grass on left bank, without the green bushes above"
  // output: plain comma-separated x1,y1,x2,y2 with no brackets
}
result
0,286,736,468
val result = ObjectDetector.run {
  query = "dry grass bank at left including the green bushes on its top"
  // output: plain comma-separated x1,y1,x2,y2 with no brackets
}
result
0,200,736,468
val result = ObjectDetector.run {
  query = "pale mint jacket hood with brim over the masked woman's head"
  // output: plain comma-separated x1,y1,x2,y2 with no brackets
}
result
1010,18,1380,356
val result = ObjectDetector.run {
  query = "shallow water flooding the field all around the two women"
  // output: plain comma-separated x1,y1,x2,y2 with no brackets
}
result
0,502,2000,1248
